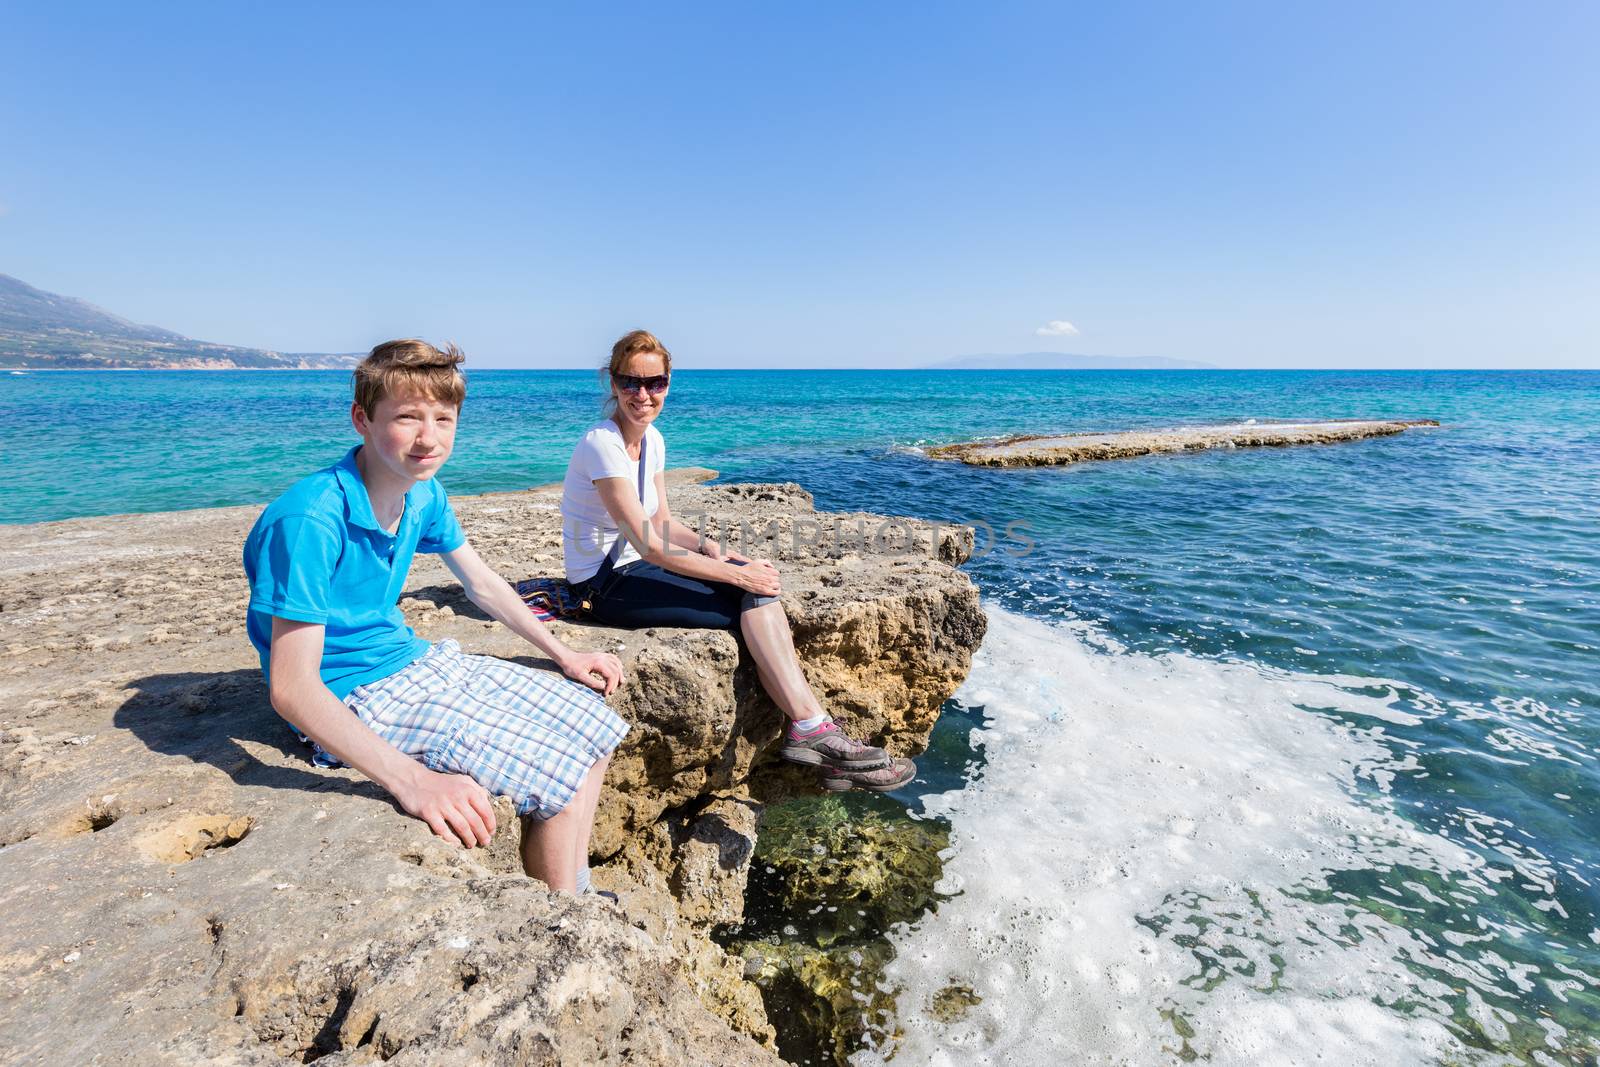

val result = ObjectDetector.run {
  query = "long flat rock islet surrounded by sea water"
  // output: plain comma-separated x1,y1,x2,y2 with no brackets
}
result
928,419,1438,467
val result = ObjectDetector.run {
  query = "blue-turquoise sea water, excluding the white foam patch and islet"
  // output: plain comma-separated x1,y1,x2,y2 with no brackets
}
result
0,371,1600,1062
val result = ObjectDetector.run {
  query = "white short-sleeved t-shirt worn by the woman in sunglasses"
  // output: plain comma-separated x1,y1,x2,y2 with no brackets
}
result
562,419,667,582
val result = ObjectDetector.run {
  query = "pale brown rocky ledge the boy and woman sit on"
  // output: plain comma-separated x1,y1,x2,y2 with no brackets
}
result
0,472,986,1064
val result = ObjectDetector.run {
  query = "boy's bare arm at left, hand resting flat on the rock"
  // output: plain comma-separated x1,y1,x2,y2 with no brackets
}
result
270,617,494,848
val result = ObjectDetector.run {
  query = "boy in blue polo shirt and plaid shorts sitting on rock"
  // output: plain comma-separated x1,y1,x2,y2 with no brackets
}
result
245,339,627,893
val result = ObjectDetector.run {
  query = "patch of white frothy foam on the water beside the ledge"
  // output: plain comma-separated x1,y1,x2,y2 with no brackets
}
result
854,605,1526,1067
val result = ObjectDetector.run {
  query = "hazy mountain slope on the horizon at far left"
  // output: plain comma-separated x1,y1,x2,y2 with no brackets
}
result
0,274,360,370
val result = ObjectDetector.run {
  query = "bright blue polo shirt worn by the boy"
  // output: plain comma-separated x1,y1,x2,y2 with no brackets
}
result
245,445,467,701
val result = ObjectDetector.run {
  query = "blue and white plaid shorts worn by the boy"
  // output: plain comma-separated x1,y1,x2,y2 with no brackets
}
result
317,640,627,819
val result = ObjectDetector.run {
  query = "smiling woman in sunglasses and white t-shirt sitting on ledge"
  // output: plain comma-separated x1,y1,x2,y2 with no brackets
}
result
562,330,917,792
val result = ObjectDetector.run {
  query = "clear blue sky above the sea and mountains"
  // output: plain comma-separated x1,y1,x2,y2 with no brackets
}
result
0,0,1600,368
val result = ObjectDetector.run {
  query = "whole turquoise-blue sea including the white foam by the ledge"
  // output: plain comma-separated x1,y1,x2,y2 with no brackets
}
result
0,368,1600,1067
